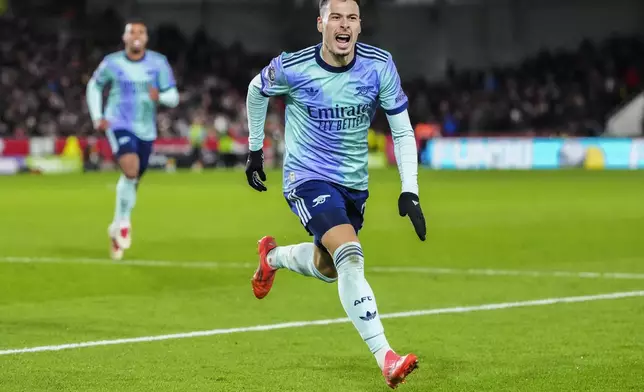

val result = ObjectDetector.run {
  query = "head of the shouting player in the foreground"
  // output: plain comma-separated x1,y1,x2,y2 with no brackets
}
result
318,0,361,57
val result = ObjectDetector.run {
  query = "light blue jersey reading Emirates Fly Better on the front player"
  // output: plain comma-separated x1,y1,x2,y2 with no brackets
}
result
261,43,408,192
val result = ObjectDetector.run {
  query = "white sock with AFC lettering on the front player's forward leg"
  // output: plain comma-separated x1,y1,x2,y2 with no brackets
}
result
333,242,391,369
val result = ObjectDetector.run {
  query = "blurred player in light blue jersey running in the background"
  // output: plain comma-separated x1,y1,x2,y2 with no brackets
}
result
86,21,179,260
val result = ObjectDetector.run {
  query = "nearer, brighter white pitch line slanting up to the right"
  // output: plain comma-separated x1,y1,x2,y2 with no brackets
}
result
0,291,644,356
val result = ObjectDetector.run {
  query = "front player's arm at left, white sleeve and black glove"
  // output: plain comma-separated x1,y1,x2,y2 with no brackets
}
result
246,75,269,192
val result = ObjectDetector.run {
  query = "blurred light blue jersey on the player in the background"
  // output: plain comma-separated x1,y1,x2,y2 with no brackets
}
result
92,50,176,141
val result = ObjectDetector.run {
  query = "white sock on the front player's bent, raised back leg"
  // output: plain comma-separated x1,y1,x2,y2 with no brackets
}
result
267,243,337,283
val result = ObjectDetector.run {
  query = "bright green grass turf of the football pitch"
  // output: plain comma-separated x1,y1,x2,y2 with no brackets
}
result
0,170,644,392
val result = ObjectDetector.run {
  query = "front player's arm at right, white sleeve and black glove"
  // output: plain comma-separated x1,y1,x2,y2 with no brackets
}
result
387,110,427,241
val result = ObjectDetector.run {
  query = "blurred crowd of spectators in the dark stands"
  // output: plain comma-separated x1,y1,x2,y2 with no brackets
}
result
0,10,644,139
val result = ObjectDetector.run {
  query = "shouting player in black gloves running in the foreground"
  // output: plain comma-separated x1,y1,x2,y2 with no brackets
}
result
246,0,426,388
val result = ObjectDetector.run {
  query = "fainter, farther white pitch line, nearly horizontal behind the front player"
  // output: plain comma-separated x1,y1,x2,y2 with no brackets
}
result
0,256,644,280
